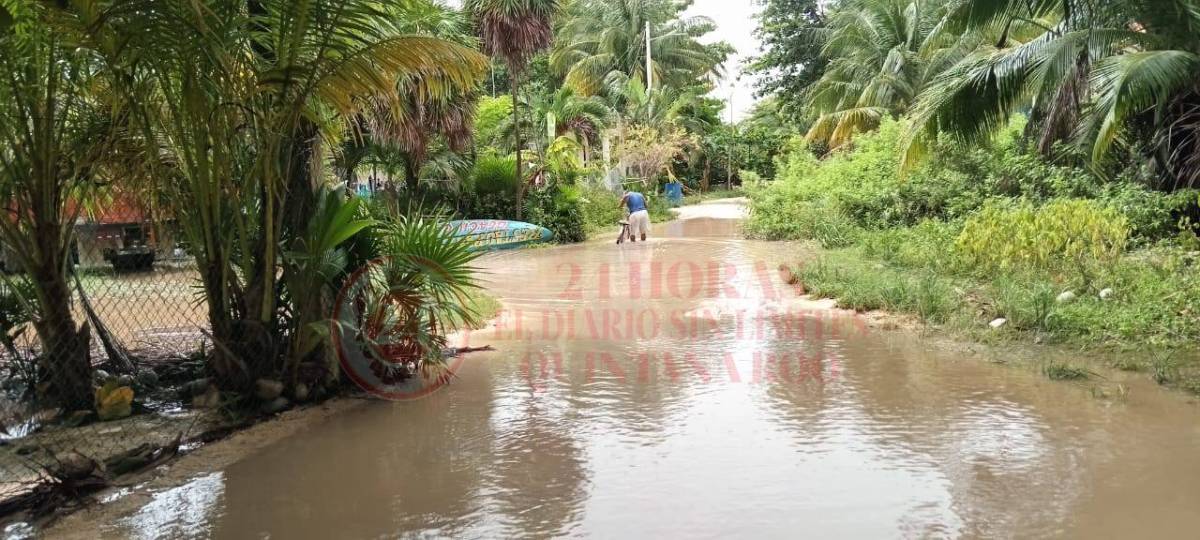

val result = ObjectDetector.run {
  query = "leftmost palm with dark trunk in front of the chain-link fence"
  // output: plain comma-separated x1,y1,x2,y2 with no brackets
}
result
0,2,113,410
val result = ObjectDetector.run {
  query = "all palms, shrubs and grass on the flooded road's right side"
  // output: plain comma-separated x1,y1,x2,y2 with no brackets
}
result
748,0,1200,391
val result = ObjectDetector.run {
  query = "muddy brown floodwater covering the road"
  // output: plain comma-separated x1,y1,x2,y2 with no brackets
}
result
37,203,1200,539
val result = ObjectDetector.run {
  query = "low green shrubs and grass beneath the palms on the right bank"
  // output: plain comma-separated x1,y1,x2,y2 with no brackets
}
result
748,118,1200,389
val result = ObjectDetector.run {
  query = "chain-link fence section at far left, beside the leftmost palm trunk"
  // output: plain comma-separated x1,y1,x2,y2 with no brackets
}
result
0,222,226,515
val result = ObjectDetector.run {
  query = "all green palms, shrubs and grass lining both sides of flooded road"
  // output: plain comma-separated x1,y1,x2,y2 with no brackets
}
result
0,0,1200,415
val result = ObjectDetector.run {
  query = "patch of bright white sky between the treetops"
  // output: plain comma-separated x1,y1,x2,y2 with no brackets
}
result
686,0,761,120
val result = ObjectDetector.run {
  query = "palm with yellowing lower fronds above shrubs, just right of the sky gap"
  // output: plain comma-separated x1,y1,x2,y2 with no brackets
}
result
805,0,973,148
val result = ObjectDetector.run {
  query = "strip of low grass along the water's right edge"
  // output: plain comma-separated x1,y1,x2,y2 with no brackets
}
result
791,241,1200,395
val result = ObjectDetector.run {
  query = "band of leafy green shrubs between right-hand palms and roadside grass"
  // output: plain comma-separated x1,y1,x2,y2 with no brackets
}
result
750,116,1200,244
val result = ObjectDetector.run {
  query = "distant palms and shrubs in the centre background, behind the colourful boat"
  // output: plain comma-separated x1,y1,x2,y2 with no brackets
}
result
359,0,768,238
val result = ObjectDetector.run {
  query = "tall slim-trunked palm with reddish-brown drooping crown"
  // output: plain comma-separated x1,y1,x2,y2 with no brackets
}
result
466,0,559,220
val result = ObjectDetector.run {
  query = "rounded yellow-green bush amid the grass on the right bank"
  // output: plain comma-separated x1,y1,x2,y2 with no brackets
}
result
955,199,1129,282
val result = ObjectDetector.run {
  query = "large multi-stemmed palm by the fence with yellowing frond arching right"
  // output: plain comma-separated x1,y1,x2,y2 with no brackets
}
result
59,0,486,389
